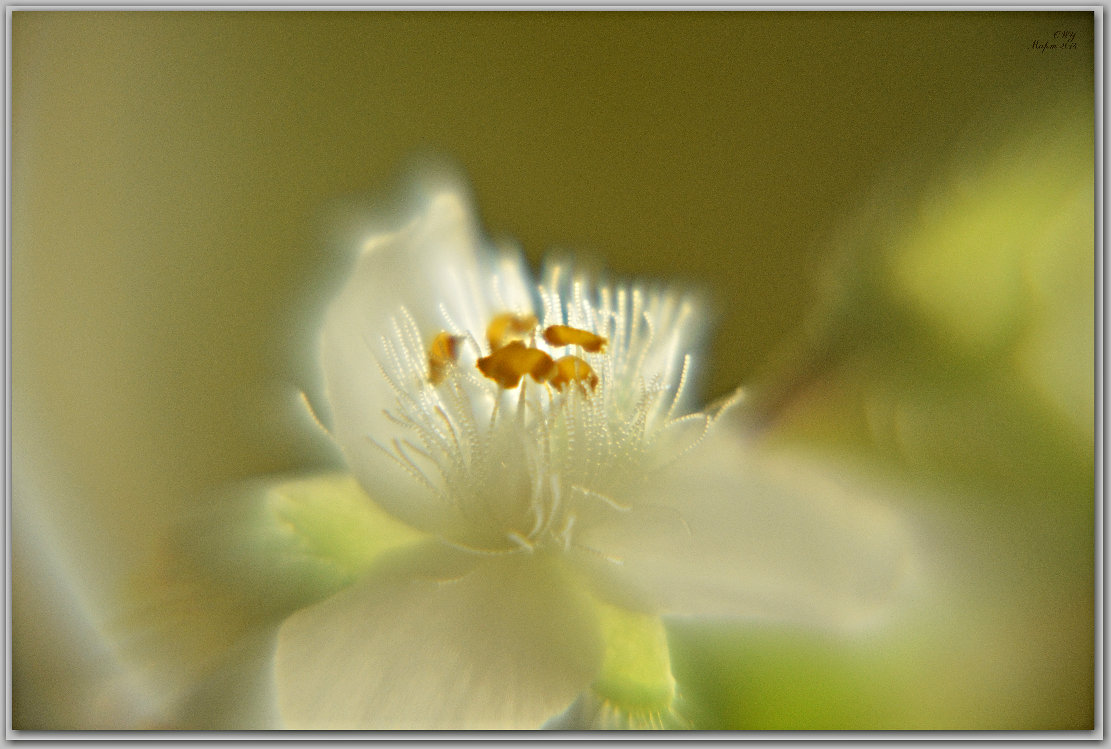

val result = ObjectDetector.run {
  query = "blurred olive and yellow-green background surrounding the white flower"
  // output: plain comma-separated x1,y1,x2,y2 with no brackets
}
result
11,11,1095,729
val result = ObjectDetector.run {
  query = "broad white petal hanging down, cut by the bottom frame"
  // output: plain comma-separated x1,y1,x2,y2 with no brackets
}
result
276,544,601,730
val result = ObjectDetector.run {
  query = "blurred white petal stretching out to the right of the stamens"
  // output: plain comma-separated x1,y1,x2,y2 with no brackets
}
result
577,423,914,627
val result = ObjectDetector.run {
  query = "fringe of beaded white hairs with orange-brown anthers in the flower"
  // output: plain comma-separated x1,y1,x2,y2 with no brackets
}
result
376,271,711,552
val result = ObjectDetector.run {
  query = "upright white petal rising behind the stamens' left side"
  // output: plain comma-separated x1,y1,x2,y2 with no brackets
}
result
321,191,532,531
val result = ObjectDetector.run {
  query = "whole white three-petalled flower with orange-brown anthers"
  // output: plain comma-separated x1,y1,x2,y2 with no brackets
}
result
276,183,904,729
